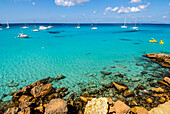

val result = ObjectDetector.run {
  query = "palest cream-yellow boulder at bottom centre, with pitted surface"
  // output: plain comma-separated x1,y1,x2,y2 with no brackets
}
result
84,98,108,114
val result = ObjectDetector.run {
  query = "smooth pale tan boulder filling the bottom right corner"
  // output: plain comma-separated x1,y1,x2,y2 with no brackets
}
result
148,101,170,114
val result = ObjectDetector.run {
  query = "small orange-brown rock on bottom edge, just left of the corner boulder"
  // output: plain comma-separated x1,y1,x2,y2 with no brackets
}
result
130,106,148,114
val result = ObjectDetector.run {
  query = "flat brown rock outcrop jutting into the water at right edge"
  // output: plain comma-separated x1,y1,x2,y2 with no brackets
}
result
143,53,170,68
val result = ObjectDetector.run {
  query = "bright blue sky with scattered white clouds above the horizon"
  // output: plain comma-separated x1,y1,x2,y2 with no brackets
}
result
0,0,170,24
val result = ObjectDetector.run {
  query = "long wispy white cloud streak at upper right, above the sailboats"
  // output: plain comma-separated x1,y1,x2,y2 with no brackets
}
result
105,2,150,13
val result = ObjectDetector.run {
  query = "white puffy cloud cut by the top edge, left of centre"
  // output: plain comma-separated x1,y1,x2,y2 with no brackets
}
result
55,0,90,6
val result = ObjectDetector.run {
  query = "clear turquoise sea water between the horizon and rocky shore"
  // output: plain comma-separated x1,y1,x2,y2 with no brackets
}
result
0,24,170,100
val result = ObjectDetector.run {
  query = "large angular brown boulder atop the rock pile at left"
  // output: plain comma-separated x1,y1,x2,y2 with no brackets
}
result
30,84,53,97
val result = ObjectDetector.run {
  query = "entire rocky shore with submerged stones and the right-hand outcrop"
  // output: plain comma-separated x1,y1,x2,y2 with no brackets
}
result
0,54,170,114
